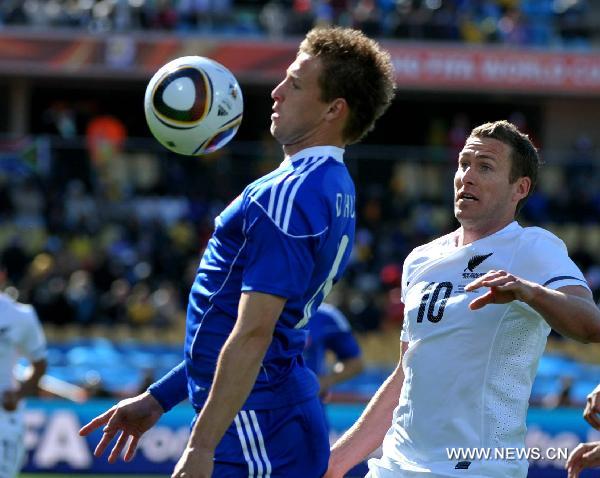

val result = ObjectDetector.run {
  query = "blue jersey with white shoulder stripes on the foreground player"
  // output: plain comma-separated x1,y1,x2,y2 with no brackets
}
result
185,146,355,409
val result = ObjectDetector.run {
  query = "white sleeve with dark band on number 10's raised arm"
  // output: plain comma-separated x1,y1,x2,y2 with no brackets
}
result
515,228,589,289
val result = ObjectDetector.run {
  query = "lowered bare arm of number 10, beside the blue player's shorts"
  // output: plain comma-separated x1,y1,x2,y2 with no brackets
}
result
323,342,408,478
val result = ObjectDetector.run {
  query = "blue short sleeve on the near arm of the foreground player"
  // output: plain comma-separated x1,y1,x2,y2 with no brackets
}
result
242,185,327,299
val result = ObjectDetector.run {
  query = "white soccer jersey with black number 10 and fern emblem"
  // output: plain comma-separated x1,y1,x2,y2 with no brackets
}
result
369,222,588,478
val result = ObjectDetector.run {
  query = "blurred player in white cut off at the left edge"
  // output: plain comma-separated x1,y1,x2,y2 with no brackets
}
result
0,292,46,478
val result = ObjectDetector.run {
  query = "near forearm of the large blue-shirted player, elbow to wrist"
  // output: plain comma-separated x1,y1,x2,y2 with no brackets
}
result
189,333,272,450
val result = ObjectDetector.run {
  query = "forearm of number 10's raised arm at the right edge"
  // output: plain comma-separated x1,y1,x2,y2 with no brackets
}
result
527,286,600,343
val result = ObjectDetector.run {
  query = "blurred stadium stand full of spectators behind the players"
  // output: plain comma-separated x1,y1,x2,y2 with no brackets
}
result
0,0,600,474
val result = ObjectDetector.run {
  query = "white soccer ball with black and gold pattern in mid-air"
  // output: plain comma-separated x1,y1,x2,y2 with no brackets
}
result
144,56,244,156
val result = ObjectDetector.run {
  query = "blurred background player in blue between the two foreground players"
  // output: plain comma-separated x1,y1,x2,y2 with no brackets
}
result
304,303,364,408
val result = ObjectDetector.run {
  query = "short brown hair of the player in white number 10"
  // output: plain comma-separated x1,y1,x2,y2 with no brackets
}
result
470,120,541,214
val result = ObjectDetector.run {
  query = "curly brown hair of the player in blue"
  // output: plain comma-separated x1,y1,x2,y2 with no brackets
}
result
299,27,395,143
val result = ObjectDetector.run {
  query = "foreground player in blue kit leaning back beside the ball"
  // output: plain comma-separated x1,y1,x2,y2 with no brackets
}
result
81,28,394,478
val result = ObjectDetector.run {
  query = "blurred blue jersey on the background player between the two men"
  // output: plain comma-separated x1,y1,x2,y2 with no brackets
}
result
304,304,361,375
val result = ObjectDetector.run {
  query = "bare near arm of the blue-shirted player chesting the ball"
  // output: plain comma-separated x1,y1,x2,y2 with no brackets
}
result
172,292,286,478
